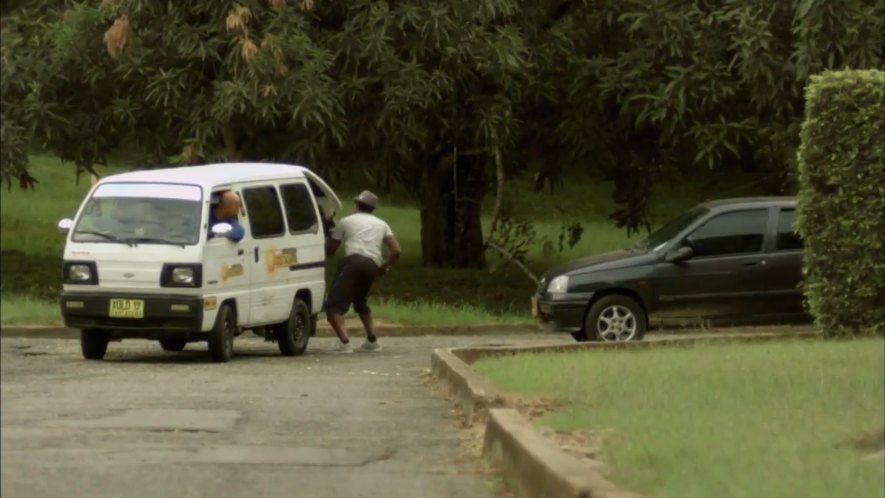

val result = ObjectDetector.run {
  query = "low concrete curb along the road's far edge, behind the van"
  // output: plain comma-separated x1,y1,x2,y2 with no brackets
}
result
0,325,539,339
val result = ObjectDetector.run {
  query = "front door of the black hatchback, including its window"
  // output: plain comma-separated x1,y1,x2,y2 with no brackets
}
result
653,208,770,317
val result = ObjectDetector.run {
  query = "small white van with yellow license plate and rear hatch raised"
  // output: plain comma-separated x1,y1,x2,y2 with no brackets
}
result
58,163,341,362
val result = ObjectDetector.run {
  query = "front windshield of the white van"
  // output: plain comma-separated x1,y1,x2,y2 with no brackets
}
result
72,183,202,246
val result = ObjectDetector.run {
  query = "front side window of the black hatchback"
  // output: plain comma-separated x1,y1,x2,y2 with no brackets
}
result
686,209,768,257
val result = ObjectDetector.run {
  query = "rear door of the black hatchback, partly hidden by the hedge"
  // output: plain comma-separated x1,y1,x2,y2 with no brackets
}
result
763,207,805,314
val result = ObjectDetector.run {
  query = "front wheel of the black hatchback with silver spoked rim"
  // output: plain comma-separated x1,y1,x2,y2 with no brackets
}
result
584,295,647,342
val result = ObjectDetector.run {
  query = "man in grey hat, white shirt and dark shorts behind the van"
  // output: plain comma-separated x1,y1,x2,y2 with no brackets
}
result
326,190,401,353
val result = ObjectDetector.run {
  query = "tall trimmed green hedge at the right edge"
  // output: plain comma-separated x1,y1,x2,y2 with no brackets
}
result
797,70,885,337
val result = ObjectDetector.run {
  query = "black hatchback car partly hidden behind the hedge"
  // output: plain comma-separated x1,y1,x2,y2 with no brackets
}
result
532,197,807,341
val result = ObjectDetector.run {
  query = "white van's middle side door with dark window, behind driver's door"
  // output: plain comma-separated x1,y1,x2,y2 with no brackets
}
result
242,182,292,326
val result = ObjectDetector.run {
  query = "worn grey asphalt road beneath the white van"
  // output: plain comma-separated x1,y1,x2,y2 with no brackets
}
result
0,334,571,498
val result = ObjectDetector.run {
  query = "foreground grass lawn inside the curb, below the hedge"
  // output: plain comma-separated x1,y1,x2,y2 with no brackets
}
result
475,339,885,498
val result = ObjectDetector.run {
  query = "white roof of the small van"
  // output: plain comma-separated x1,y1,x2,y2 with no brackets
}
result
99,163,309,189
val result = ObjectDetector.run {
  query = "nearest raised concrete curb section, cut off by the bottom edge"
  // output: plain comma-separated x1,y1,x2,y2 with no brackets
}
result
483,408,641,498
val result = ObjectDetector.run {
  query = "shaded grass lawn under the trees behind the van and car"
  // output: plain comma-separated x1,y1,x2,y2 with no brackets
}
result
0,155,760,325
